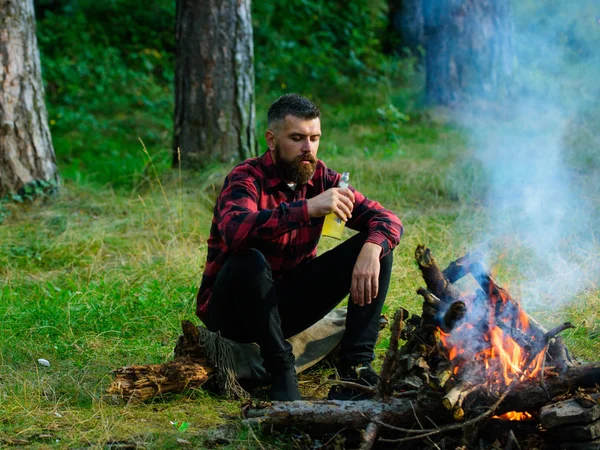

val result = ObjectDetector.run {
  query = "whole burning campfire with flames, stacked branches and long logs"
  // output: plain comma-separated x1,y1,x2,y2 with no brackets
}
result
245,245,600,449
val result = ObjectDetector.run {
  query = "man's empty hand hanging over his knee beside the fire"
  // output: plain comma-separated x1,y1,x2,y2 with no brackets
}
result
350,242,382,306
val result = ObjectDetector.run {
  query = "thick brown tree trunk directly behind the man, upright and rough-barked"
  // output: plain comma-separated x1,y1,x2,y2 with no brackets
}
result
173,0,257,169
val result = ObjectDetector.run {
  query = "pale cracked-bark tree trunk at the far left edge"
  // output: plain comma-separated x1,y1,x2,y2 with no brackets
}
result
0,0,58,197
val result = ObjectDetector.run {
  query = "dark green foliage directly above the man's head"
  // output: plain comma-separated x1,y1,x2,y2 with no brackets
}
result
252,0,393,100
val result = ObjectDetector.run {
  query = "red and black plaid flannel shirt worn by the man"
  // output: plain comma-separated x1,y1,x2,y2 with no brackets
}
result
196,151,403,320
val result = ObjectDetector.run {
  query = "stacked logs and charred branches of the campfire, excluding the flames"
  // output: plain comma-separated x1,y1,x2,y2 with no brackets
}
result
244,246,600,448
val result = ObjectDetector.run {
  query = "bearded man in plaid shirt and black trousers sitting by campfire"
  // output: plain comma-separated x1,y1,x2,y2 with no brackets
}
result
196,94,403,401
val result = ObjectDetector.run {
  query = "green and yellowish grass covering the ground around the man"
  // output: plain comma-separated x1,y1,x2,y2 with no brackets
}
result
0,94,600,448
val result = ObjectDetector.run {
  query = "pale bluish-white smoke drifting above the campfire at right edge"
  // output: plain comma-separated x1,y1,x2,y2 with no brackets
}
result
454,0,600,308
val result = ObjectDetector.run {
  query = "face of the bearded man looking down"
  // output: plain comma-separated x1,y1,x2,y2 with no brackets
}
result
266,115,321,184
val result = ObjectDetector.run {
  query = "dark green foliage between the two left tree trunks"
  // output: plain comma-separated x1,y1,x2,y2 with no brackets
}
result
36,0,175,188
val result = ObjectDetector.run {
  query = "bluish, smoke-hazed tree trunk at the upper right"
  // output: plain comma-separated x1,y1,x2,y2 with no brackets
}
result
423,0,515,106
